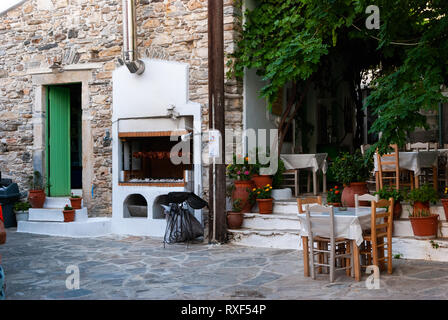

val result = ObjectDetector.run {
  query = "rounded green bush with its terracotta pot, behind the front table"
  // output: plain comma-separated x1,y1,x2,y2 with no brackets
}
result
331,150,373,207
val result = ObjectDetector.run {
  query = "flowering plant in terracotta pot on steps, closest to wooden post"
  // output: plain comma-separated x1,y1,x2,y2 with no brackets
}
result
226,155,254,213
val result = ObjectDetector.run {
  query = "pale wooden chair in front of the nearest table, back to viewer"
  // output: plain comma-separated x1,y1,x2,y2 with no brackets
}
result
305,205,354,282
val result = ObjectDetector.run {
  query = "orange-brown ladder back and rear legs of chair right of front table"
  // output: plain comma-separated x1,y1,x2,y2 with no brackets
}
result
370,198,394,273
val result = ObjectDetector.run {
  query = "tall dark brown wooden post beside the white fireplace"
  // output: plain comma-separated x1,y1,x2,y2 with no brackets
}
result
208,0,227,243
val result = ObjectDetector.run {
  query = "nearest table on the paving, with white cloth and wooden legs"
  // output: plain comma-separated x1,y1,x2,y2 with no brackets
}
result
297,205,386,281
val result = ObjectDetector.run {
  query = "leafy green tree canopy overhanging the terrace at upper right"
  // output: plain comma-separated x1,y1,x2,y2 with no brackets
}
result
229,0,448,155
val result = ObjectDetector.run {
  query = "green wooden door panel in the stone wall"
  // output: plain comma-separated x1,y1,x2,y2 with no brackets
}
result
47,86,71,197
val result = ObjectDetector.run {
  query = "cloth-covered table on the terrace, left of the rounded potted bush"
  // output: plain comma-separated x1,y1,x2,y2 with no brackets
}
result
280,153,328,195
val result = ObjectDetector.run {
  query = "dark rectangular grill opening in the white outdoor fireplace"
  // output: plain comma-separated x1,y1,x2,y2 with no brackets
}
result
120,136,193,184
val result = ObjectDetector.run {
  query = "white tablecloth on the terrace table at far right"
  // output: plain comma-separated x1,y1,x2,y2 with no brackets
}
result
374,151,439,176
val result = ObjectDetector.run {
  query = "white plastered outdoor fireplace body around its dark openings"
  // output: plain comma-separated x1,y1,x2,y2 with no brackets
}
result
112,59,202,237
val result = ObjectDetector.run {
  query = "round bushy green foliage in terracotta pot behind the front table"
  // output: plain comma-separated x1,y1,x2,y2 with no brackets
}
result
330,150,373,185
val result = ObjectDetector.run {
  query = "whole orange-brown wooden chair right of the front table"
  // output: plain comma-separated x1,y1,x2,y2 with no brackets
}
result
360,198,394,274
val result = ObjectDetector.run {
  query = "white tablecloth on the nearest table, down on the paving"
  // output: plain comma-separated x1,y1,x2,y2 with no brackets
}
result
297,206,385,246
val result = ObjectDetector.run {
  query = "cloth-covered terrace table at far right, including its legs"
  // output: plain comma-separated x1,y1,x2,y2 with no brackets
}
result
374,150,439,189
